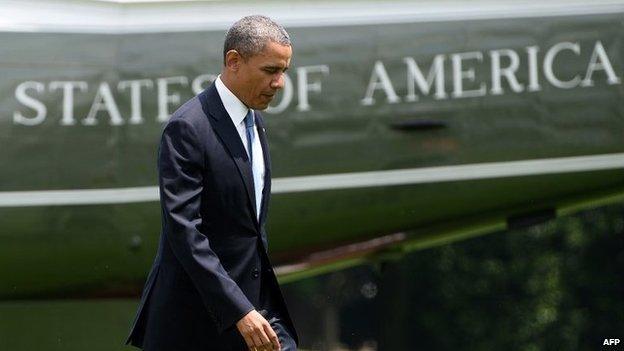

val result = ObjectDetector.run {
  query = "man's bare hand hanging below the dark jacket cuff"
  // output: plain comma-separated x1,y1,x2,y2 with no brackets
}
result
236,310,282,351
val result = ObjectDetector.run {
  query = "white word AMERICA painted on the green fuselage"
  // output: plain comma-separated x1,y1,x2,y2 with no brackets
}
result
360,41,621,106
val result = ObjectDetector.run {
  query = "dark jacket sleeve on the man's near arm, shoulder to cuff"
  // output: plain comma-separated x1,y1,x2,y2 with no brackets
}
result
158,118,254,333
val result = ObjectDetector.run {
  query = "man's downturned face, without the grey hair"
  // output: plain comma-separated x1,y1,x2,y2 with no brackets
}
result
229,42,292,110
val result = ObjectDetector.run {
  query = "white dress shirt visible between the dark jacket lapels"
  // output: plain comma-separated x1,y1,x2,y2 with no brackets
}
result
215,75,265,219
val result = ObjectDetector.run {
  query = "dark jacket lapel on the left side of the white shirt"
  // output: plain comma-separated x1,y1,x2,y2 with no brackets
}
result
198,83,259,228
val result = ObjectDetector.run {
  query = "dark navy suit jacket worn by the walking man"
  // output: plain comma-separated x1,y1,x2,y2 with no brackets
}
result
126,83,298,351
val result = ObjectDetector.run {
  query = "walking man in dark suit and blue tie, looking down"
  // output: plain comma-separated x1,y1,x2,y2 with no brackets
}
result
126,16,298,351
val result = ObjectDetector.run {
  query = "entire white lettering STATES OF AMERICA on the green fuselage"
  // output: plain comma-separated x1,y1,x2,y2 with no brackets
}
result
13,41,621,126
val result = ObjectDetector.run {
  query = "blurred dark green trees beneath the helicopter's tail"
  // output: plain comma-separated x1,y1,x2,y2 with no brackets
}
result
378,204,624,350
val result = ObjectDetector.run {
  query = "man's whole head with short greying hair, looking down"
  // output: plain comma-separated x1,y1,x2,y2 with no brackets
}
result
221,16,292,110
